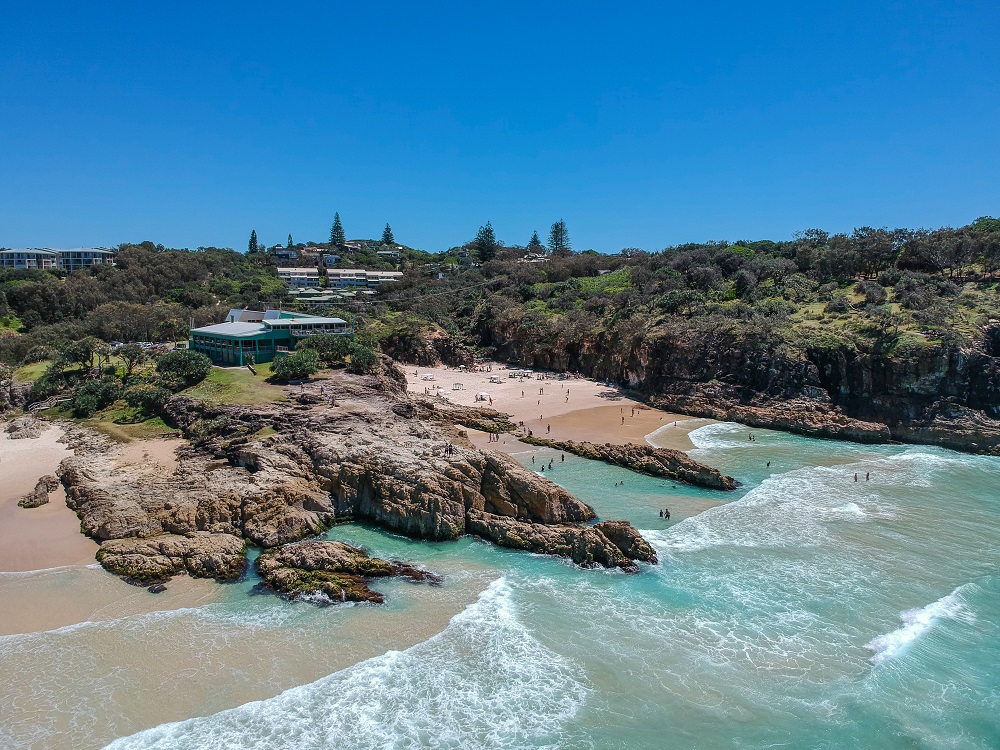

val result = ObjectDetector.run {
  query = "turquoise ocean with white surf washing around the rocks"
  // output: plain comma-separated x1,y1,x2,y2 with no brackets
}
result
0,423,1000,750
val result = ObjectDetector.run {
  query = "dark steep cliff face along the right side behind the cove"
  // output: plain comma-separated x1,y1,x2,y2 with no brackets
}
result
474,324,1000,454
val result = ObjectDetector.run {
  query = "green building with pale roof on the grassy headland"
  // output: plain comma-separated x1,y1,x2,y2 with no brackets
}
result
188,309,354,367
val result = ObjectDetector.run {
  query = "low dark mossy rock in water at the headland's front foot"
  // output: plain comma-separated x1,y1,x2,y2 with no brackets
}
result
257,541,441,604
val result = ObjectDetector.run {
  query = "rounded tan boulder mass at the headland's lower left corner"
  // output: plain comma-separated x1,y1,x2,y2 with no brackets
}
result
97,532,246,586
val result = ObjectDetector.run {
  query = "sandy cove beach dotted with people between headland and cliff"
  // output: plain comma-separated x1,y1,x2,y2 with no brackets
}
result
406,362,714,453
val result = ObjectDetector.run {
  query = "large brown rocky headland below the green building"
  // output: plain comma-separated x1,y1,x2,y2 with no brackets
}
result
58,365,680,584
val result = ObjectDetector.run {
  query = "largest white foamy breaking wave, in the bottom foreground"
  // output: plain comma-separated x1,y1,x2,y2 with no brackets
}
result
109,579,590,750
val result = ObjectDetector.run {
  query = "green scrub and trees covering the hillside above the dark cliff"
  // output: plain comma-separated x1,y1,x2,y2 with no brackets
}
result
379,217,1000,362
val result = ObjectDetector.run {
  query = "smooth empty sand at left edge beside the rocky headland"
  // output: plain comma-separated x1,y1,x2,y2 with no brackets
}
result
0,426,97,571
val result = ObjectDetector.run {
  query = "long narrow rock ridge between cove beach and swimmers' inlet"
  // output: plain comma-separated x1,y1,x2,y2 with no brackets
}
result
519,436,736,490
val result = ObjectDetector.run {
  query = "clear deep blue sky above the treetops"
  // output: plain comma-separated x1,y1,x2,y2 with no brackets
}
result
0,0,1000,252
